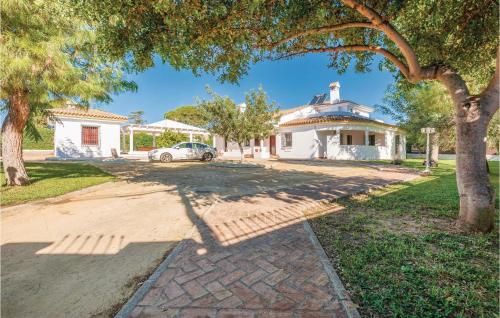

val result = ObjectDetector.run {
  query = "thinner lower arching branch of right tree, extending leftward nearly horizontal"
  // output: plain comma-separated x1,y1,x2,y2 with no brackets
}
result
279,45,409,78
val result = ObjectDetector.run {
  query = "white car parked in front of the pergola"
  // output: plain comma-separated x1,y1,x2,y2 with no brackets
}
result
148,142,217,162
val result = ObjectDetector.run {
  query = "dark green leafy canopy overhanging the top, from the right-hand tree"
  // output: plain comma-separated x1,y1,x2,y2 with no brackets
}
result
80,0,498,84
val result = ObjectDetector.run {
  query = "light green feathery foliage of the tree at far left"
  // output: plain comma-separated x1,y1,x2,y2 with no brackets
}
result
0,0,136,133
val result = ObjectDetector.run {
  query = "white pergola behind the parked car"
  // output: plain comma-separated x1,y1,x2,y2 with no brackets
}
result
122,119,210,153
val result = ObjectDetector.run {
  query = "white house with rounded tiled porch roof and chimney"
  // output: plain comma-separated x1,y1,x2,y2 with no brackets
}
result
216,82,406,160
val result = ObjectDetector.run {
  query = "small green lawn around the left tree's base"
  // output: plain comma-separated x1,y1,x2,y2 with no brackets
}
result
0,163,114,206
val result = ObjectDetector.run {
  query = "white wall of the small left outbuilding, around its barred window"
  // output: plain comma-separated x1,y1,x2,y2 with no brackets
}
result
54,118,120,158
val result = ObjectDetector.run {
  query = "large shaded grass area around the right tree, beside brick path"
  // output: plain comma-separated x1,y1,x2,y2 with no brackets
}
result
311,160,499,317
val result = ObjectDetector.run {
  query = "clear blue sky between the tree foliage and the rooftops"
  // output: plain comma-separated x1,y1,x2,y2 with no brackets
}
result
100,54,393,123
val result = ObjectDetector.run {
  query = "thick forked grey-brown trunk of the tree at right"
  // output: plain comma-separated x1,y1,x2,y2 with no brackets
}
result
437,65,499,232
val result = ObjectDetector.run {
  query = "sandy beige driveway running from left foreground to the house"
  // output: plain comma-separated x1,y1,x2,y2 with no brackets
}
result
1,161,415,317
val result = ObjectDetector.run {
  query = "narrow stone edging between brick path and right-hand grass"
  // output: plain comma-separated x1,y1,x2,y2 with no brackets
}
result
302,220,361,318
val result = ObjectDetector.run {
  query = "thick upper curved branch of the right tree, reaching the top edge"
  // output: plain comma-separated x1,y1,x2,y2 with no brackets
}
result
341,0,421,82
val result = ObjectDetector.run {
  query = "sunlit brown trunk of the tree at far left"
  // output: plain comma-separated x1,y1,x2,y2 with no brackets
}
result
2,91,30,185
